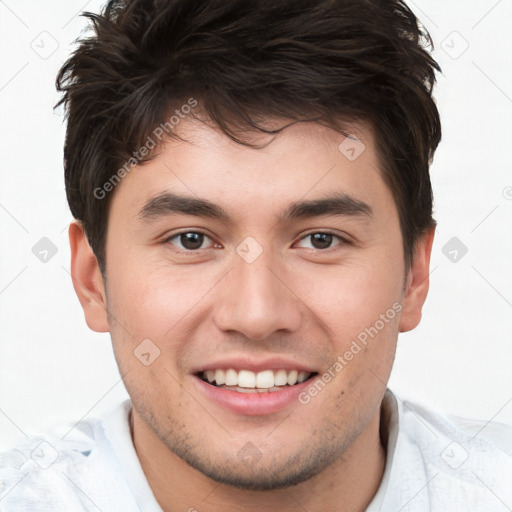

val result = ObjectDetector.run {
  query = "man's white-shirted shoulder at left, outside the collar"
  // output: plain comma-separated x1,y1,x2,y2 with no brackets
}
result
0,404,134,512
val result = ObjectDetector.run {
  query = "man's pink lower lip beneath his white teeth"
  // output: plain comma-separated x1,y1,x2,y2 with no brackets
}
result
194,375,318,416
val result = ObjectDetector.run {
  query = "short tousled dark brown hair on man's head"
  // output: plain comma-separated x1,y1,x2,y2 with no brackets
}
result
56,0,441,273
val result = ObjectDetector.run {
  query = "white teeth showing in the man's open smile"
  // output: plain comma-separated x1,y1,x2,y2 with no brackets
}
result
197,368,318,393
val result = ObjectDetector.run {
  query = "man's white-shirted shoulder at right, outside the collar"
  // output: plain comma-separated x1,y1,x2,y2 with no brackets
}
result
385,393,512,511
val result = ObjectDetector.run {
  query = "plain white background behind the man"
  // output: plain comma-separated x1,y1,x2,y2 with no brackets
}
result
0,0,512,448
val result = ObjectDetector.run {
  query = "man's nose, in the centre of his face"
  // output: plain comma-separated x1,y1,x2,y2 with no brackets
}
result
214,247,303,341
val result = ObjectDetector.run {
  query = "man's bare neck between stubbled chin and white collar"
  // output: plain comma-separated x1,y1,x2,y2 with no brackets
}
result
130,410,386,512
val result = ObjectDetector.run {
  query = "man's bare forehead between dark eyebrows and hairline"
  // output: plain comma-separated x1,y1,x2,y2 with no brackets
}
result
111,120,391,226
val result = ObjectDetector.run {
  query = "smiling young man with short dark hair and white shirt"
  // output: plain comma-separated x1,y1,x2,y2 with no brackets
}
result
0,0,512,512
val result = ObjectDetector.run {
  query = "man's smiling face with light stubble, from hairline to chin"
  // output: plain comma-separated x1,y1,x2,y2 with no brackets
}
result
72,121,432,490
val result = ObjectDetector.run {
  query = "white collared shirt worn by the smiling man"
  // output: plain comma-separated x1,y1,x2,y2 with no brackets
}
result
0,390,512,512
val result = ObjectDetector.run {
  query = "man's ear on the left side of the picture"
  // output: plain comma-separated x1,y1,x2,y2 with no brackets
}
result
69,220,109,332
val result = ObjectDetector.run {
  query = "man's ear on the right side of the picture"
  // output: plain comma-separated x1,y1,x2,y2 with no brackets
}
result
400,228,435,332
